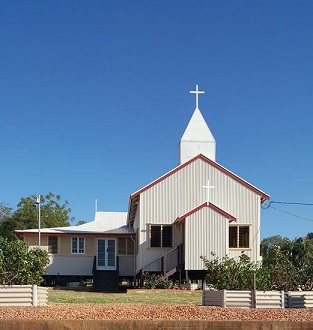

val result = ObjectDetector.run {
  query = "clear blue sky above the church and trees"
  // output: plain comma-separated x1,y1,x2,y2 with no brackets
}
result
0,0,313,238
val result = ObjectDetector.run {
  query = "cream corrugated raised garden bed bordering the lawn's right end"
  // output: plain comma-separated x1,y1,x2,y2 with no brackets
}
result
202,290,288,308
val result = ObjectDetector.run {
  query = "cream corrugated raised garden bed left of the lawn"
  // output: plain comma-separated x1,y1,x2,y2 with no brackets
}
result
0,285,48,306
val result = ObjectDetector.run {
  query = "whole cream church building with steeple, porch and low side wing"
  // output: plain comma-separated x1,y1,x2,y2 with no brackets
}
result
16,85,269,289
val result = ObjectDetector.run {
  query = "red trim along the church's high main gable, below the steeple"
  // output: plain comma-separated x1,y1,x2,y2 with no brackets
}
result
130,154,270,202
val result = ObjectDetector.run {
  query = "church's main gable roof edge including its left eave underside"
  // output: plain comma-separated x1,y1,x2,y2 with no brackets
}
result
127,154,270,222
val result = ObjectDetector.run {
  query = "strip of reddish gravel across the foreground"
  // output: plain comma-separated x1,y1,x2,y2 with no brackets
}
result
0,304,313,321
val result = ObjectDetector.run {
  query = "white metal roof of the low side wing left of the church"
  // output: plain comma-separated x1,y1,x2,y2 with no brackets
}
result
15,212,134,234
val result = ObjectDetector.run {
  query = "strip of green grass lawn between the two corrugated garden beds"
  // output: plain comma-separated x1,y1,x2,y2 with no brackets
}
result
49,288,202,305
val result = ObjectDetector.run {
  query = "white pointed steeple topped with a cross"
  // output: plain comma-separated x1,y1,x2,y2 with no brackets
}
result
178,85,215,164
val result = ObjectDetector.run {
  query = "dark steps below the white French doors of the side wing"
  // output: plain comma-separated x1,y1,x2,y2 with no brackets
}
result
93,270,119,292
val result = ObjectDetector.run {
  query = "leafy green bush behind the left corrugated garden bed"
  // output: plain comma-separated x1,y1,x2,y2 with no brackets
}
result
0,237,49,285
